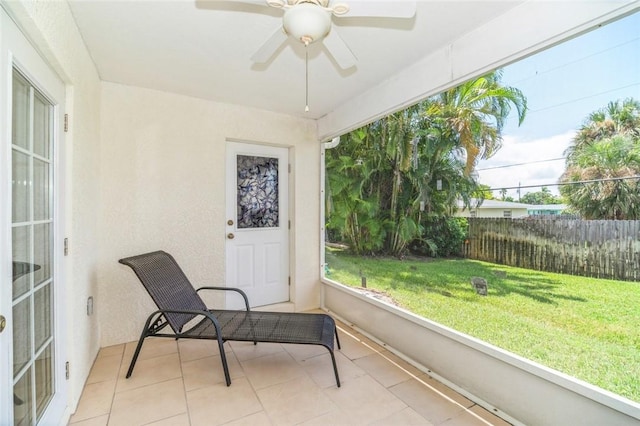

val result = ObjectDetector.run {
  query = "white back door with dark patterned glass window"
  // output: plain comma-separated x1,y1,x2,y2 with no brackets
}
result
225,142,289,308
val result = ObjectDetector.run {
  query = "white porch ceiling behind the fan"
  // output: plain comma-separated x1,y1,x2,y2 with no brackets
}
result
69,0,523,118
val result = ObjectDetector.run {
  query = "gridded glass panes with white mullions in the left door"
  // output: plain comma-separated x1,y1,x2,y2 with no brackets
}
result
11,69,59,425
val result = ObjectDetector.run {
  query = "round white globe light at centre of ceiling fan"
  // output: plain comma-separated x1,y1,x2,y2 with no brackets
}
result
283,3,331,44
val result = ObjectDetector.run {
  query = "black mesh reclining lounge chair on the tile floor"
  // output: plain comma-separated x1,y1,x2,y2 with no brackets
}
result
119,251,340,387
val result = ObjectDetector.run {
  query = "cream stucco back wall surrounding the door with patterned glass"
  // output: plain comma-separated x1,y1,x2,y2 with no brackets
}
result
97,83,320,346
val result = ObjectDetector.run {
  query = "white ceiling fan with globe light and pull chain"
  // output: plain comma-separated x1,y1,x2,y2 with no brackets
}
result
228,0,416,69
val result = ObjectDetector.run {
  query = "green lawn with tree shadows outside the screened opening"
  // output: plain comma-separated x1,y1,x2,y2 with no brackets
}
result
326,248,640,402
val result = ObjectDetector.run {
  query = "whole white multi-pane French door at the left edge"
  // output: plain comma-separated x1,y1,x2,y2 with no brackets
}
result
0,9,67,425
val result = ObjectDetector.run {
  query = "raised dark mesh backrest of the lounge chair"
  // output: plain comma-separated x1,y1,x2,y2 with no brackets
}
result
118,251,207,333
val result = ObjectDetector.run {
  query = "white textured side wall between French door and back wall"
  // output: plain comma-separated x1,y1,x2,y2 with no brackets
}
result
5,1,101,410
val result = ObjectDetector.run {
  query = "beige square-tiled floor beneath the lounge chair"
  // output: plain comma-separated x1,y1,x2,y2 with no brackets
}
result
70,324,508,426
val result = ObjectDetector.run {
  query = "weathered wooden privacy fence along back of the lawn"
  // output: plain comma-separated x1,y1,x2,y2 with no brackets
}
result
462,218,640,281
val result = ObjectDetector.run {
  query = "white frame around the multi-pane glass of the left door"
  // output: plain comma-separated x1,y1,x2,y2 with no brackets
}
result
0,7,69,424
